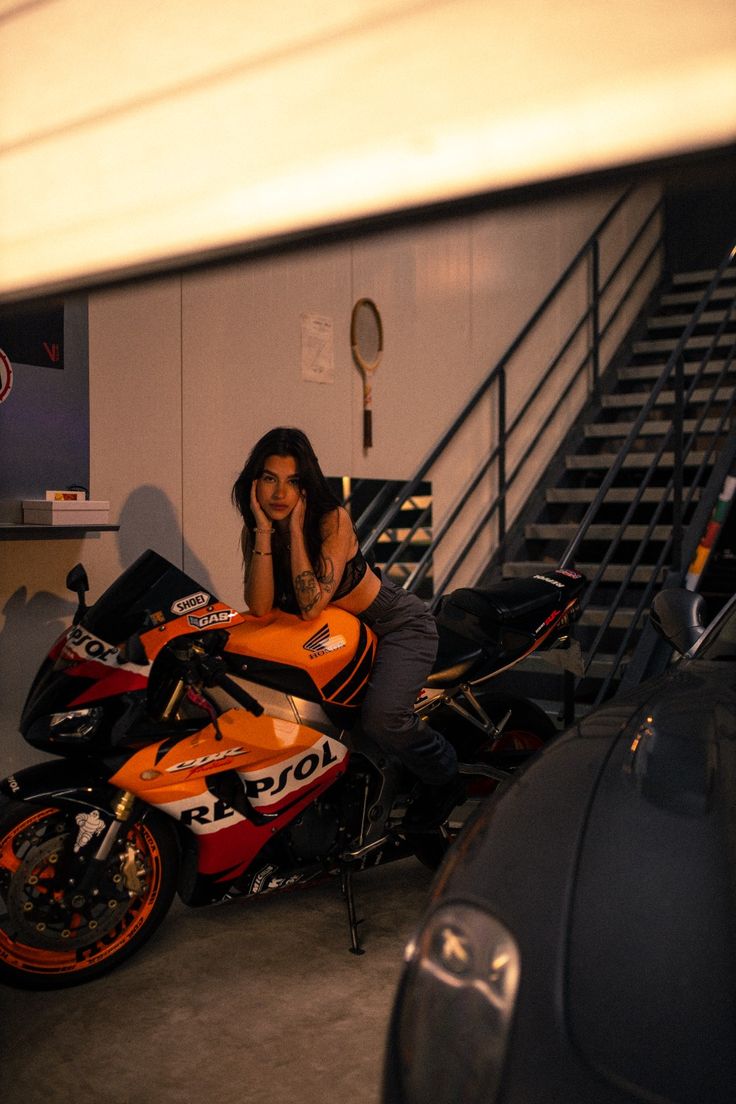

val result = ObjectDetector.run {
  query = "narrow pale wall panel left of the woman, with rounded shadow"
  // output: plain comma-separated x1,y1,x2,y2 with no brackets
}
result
89,277,186,586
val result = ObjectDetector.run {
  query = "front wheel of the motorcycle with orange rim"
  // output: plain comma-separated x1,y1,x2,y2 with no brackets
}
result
0,802,179,989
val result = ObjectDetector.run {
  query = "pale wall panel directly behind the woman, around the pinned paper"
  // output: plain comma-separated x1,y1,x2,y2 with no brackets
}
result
182,245,358,603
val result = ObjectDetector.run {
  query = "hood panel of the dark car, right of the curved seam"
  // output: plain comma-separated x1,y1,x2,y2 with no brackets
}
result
566,661,736,1104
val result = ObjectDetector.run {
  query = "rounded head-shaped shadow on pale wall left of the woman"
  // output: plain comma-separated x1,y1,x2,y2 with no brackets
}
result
116,484,214,594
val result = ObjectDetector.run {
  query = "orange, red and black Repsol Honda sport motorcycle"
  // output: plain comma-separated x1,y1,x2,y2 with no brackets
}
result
0,551,584,988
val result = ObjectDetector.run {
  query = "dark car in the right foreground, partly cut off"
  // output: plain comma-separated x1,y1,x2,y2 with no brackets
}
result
383,591,736,1104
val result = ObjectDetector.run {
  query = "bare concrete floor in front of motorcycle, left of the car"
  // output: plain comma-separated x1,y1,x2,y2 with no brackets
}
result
0,859,433,1104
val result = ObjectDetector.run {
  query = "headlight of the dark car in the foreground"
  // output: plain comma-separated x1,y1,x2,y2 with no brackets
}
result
392,904,521,1104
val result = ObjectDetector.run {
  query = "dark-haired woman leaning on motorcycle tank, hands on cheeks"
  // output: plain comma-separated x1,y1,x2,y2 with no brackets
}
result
233,427,458,794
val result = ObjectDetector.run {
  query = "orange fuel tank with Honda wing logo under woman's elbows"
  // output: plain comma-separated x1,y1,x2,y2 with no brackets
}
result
227,606,376,705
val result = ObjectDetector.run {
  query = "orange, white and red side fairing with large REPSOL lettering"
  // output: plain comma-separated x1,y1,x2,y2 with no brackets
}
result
110,709,348,877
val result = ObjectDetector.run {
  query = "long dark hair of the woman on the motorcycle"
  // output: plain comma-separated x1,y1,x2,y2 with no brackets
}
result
233,425,340,573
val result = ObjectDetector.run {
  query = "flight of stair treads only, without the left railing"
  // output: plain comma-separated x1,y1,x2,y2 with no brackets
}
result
501,262,736,711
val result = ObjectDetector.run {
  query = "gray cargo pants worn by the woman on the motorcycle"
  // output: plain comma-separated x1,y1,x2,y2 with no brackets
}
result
359,576,458,785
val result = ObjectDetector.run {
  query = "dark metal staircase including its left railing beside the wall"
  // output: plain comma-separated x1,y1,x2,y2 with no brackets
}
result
353,189,736,716
